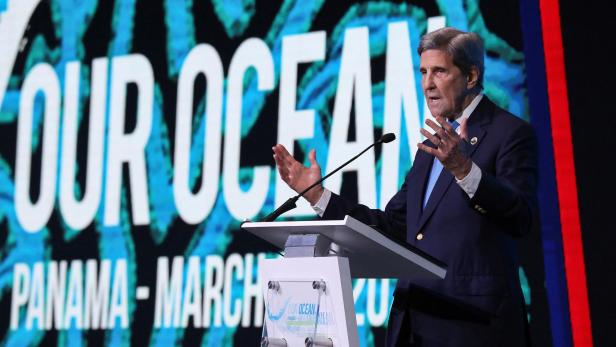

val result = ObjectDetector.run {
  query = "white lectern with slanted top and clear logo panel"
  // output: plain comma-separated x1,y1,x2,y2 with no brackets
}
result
242,216,446,347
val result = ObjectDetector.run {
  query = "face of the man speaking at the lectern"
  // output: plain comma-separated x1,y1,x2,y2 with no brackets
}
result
419,49,470,120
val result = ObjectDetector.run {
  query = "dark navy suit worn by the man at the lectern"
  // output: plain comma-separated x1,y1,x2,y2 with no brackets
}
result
322,96,538,346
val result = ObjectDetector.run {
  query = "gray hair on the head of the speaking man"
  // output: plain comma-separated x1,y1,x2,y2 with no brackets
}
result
417,27,485,90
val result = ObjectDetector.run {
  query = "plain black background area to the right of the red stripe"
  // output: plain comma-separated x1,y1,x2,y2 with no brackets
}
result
560,1,616,346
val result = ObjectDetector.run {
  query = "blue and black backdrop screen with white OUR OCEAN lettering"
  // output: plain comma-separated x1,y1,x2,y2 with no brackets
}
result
0,0,567,346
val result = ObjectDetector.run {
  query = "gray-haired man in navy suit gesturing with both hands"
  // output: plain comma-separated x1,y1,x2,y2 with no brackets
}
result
273,28,538,346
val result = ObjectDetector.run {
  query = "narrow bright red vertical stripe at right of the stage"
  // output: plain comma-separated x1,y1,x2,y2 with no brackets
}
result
539,0,592,347
